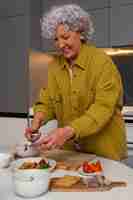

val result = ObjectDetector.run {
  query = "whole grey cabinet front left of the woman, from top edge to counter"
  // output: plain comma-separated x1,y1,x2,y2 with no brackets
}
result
0,0,41,113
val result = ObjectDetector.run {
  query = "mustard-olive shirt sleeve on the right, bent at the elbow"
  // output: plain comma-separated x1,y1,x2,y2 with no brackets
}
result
69,54,123,139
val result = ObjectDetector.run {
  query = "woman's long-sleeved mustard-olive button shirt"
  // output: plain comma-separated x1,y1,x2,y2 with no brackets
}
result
34,44,127,160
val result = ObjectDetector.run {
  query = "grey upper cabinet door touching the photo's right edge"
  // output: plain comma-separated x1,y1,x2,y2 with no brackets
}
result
111,5,133,46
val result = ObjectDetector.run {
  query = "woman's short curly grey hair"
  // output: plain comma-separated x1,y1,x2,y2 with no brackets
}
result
41,4,94,42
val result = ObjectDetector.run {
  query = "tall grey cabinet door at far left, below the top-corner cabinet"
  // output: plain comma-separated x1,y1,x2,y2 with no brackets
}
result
0,16,29,113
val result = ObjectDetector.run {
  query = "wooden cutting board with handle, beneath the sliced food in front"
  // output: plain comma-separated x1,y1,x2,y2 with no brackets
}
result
49,177,126,192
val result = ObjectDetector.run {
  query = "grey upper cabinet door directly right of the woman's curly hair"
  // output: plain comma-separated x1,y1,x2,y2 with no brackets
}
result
91,8,109,47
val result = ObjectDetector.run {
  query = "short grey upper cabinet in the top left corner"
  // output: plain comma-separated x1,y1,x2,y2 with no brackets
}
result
0,0,30,17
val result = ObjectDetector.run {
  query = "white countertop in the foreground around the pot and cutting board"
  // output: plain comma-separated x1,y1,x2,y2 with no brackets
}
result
0,158,133,200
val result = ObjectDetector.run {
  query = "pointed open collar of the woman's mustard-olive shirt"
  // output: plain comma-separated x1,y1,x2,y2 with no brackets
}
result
61,43,87,70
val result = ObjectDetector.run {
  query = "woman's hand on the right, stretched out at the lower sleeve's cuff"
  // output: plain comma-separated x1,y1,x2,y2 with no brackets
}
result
34,127,74,151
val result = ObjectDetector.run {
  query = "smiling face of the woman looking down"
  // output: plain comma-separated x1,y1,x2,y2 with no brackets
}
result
55,24,81,60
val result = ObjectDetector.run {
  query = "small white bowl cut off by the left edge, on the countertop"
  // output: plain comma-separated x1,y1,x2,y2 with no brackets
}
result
0,153,12,168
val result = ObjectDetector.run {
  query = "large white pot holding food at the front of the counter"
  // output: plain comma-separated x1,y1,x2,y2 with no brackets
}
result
11,157,56,198
